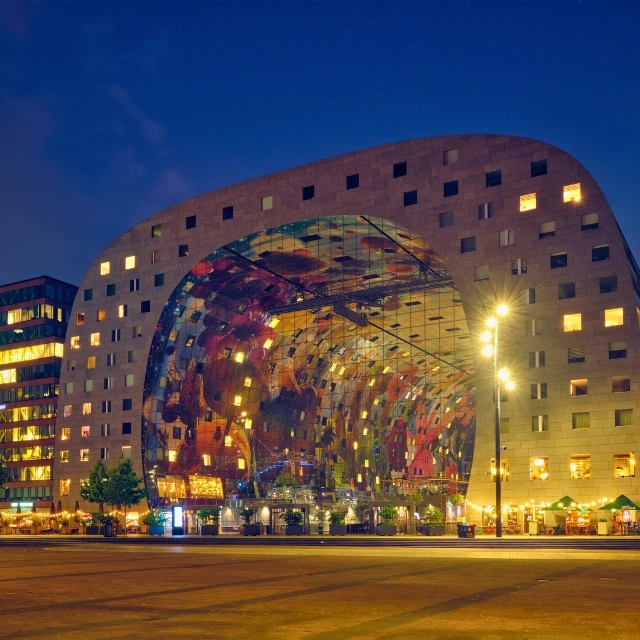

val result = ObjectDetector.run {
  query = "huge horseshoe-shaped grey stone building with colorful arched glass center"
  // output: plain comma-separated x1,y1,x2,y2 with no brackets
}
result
54,135,640,532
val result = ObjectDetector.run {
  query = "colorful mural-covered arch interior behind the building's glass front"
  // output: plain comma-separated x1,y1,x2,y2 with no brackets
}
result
143,216,475,504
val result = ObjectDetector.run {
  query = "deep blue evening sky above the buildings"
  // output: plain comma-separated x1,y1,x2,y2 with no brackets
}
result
0,1,640,284
